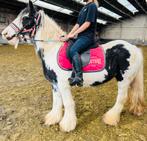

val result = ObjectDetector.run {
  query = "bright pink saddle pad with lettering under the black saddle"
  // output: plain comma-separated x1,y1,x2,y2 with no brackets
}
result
57,42,105,72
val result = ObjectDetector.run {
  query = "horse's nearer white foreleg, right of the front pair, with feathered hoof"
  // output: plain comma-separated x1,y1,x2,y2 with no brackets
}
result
59,81,77,132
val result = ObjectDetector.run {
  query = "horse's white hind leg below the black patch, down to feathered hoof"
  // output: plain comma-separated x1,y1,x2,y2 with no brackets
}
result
103,80,129,125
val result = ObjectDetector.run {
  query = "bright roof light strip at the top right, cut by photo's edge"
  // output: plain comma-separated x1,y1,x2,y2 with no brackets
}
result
117,0,139,14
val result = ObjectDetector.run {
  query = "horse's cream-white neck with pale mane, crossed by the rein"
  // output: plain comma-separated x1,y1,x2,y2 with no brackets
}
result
35,12,64,55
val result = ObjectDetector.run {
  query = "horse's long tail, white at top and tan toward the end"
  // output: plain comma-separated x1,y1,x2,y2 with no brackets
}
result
129,49,145,116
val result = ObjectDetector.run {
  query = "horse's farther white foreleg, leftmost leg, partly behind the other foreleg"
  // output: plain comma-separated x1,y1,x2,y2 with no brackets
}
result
45,89,63,125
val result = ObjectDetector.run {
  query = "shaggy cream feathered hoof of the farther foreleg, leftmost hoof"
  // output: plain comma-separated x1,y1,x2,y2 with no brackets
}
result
45,111,62,126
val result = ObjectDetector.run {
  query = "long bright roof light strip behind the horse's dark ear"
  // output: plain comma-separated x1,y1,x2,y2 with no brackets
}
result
17,0,73,15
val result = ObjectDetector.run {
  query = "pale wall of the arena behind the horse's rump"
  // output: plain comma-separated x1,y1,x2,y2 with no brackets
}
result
101,15,147,44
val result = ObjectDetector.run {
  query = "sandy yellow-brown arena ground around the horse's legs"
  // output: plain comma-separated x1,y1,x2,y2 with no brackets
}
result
0,46,147,141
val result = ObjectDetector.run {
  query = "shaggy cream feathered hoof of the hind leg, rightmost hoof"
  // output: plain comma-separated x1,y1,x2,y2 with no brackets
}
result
103,111,120,126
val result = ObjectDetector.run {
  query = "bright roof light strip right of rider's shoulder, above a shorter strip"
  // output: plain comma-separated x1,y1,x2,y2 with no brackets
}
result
98,6,121,20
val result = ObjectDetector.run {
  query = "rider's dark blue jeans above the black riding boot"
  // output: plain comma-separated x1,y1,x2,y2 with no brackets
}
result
67,36,94,62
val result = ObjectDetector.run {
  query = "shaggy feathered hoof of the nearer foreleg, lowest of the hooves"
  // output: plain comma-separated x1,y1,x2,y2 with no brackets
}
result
60,117,77,132
